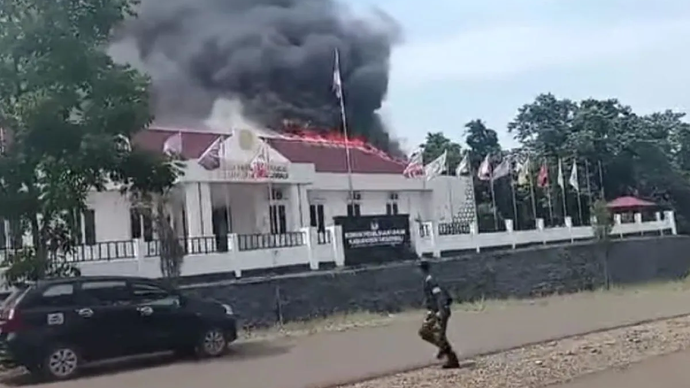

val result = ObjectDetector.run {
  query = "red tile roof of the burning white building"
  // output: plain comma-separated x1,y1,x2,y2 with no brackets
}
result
133,128,405,174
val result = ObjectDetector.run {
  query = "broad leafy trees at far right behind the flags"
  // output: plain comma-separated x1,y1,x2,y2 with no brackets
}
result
509,94,690,230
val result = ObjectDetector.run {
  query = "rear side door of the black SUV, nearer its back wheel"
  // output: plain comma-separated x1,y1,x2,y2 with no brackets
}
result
77,279,145,359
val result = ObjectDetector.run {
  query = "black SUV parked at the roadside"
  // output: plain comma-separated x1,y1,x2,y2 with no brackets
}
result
0,276,237,379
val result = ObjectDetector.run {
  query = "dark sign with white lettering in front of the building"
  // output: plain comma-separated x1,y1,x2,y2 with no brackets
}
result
334,214,416,265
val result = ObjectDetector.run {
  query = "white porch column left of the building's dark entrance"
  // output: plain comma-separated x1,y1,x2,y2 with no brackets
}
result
185,182,213,237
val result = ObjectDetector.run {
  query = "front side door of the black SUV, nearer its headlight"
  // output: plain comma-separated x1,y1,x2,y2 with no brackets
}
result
130,281,197,350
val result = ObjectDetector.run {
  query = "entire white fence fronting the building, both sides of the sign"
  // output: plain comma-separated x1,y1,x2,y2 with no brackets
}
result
0,211,676,286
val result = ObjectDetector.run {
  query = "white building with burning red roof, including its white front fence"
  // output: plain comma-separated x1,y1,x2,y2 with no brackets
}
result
0,129,676,277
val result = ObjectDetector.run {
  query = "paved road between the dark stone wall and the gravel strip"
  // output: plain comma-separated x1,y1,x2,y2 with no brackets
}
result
4,291,690,388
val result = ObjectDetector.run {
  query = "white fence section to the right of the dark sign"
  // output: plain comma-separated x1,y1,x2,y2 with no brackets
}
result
413,211,677,257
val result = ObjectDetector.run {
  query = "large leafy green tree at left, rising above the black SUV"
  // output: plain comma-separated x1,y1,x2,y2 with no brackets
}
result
0,0,178,280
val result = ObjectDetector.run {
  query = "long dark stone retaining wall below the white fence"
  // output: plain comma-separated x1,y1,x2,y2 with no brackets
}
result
181,237,690,326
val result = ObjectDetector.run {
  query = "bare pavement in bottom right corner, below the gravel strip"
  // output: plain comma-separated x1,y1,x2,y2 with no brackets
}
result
554,351,690,388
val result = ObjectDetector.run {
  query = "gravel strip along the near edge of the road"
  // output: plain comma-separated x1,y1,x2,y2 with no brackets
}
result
341,317,690,388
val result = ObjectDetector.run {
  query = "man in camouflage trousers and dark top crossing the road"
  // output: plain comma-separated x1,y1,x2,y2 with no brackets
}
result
419,260,460,369
